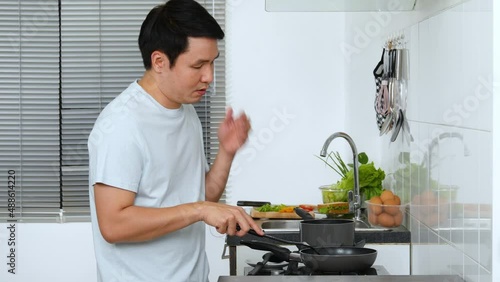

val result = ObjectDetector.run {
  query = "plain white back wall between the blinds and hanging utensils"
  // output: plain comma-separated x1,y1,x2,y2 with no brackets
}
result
226,0,348,207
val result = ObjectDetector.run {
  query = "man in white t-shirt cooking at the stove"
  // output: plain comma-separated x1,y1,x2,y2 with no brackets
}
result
88,0,263,282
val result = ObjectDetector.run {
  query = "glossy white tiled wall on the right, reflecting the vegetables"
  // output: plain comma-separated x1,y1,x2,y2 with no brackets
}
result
382,0,493,281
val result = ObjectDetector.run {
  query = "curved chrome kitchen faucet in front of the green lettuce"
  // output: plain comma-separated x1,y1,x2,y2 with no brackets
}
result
319,132,368,228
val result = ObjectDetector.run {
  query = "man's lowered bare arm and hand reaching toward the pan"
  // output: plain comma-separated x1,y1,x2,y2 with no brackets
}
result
94,183,262,243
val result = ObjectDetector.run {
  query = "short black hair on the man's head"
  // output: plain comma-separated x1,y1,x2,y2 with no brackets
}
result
139,0,224,70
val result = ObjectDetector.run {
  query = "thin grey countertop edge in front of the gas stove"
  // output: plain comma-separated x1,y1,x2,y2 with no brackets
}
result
218,275,464,282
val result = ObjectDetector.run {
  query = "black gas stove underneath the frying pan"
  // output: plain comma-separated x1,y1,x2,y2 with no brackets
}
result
244,261,389,276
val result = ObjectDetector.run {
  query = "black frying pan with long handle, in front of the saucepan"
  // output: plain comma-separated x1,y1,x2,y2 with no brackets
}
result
240,240,377,272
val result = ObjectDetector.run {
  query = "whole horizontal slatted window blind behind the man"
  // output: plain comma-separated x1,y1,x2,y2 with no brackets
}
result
0,0,225,220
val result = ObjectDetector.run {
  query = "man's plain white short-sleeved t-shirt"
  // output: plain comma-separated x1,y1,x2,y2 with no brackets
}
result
88,82,209,282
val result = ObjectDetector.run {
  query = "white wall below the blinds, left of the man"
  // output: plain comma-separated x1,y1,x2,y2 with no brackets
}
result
0,223,96,282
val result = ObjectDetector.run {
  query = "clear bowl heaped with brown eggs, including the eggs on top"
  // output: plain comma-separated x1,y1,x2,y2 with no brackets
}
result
365,190,407,228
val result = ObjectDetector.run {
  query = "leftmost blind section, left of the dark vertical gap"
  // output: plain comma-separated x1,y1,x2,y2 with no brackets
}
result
0,0,60,219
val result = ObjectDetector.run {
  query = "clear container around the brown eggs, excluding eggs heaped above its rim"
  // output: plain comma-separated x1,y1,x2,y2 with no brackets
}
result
365,201,407,228
